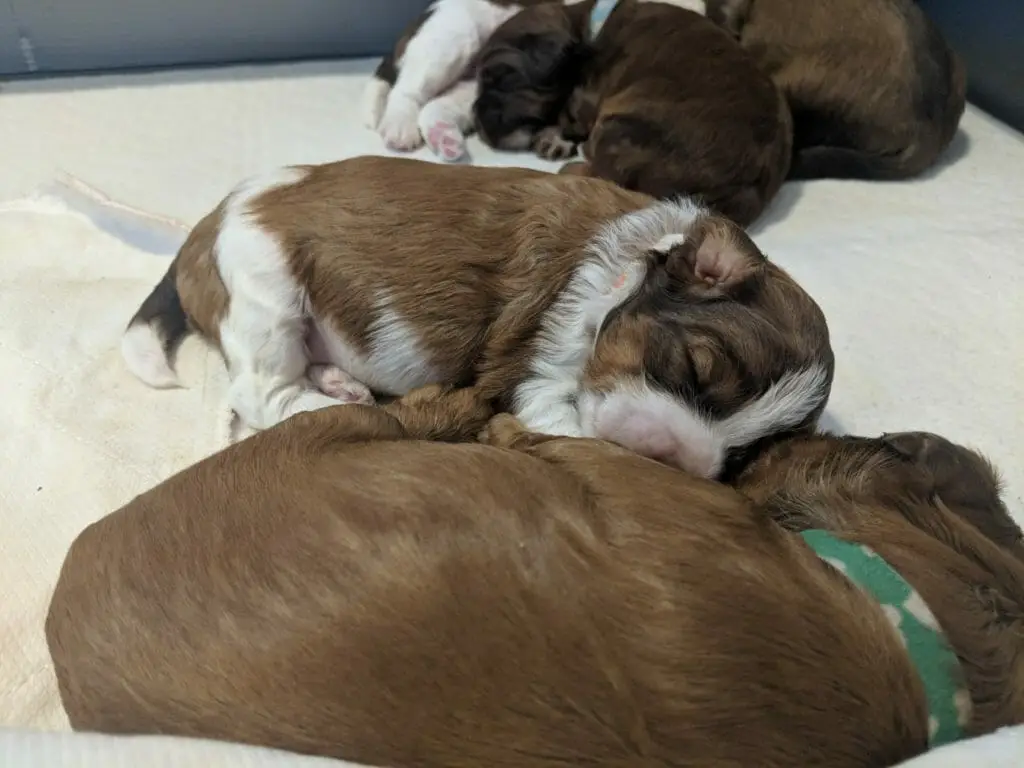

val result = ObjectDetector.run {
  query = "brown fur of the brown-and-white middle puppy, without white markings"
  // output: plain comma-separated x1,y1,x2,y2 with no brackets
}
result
125,158,833,468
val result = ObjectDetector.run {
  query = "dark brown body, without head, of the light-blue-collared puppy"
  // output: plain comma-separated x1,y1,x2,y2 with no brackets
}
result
585,3,793,225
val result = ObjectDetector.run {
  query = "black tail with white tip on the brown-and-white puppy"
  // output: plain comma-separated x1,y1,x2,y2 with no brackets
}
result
121,258,190,389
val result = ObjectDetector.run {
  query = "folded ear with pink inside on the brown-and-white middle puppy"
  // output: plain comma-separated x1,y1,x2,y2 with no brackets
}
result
652,216,768,291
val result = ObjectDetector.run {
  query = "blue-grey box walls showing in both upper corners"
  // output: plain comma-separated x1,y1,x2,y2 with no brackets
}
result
0,0,1024,130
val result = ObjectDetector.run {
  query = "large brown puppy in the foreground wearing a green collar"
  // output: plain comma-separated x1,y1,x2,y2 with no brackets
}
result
46,399,1024,768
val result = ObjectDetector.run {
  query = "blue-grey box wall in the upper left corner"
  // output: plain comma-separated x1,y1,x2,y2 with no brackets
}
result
0,0,429,75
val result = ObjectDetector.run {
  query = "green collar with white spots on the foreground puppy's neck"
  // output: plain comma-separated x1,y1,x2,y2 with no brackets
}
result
801,530,971,746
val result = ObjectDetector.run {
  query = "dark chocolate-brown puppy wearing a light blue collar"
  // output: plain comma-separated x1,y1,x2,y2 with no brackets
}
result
474,0,793,226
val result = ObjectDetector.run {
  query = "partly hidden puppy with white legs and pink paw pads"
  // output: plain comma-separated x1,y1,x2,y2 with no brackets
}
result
364,0,561,161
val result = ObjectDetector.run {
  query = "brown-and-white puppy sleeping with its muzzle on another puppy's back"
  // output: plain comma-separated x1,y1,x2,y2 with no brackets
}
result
122,158,834,476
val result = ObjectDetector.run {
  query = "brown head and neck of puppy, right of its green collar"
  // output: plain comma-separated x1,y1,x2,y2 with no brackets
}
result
737,432,1024,735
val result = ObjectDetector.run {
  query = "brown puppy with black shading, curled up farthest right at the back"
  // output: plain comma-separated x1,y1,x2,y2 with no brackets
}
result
708,0,967,180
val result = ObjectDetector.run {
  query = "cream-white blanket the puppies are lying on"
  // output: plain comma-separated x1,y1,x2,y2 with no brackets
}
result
0,61,1024,765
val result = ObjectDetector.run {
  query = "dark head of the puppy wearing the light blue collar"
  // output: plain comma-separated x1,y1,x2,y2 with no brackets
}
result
473,0,594,150
